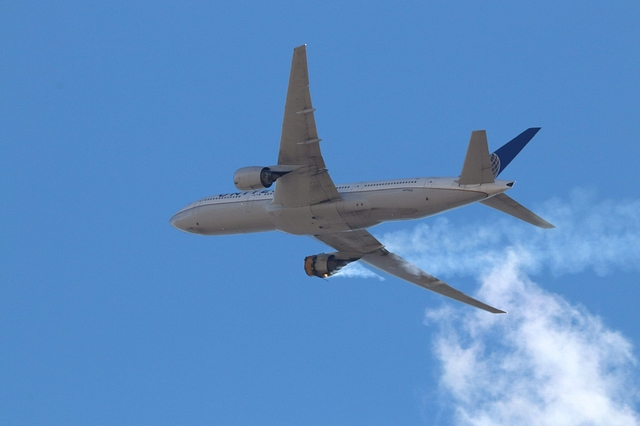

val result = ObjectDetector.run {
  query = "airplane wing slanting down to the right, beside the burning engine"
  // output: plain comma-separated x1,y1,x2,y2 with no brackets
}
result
314,229,506,314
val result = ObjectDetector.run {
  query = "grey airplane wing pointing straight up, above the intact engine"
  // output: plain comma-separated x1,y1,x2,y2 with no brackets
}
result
274,45,340,207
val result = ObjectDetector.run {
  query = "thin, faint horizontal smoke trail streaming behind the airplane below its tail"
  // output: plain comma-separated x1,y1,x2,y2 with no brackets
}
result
380,190,640,277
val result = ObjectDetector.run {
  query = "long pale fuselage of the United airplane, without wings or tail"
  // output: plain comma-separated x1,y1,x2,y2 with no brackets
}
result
171,177,513,235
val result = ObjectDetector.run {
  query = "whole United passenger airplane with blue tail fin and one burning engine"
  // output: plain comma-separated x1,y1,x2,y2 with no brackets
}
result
170,45,554,314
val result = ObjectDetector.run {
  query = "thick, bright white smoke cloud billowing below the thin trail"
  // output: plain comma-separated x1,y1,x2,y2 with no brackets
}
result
425,249,640,425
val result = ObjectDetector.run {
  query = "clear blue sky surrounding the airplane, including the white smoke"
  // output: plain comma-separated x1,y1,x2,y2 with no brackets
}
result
0,1,640,425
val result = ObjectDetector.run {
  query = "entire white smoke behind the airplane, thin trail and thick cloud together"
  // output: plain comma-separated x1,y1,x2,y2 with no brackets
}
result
380,191,640,425
